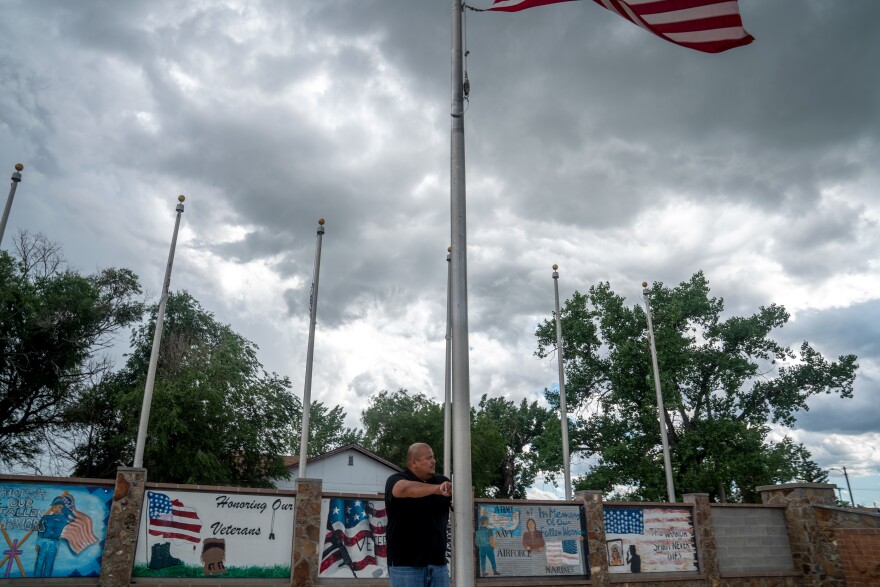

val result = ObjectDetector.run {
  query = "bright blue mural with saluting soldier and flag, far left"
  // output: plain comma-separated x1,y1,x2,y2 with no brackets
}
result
0,483,113,579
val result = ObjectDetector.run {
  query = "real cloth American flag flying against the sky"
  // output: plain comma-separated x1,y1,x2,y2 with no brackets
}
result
487,0,755,53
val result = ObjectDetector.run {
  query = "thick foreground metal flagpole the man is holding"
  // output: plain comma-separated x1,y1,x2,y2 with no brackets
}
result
450,0,474,587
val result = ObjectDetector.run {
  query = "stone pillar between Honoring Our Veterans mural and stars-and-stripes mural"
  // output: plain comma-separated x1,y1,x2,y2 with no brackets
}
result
290,479,322,587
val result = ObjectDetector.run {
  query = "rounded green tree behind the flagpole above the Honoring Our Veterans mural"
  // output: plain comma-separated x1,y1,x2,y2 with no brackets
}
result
75,292,297,486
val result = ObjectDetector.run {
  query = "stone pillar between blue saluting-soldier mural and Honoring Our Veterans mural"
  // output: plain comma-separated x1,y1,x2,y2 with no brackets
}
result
98,467,147,587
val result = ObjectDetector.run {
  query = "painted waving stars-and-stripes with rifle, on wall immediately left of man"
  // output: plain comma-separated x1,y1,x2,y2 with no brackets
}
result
319,498,388,577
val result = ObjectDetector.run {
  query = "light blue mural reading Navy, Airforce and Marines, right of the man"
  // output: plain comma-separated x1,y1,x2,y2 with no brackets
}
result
474,504,588,577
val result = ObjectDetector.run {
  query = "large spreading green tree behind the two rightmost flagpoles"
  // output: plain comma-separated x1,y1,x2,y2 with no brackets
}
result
536,272,858,501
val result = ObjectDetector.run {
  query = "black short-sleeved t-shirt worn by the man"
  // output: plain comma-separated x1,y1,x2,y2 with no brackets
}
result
385,469,452,567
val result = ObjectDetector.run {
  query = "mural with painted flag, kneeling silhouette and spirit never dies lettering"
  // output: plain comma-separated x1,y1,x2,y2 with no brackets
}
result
603,505,699,573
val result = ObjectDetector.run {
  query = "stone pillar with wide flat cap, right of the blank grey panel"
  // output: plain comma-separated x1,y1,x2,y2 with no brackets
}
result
757,483,846,587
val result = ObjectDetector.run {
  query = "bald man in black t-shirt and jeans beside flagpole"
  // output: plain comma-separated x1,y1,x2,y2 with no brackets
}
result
385,442,452,587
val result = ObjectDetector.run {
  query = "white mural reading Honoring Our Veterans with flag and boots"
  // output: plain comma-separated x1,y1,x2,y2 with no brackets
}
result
133,489,294,578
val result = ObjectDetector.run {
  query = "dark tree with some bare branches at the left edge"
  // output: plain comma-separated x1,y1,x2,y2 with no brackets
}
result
0,233,143,464
